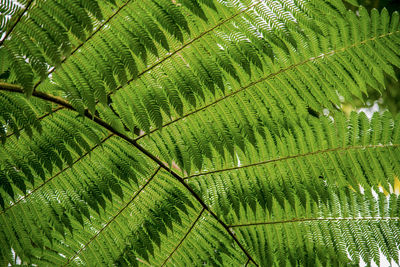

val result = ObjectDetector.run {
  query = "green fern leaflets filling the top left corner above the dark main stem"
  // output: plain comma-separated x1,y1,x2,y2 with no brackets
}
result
1,1,117,95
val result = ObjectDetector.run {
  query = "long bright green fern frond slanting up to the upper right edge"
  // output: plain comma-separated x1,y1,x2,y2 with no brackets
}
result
106,2,399,150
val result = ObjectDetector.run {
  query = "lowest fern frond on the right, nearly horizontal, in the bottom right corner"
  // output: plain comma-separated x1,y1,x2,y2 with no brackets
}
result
231,189,400,265
